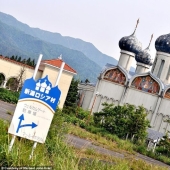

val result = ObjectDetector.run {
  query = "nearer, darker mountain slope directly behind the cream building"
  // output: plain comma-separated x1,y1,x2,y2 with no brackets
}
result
0,21,101,82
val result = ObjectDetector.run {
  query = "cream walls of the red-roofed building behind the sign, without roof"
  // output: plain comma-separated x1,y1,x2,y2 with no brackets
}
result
0,59,74,108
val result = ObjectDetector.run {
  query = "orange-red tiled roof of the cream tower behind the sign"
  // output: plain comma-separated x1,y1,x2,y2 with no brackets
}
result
42,59,77,73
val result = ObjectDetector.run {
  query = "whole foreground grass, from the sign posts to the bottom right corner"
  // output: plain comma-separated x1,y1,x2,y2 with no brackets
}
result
0,111,167,170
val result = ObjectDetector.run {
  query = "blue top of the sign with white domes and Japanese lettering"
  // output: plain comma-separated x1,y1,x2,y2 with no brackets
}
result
19,76,61,112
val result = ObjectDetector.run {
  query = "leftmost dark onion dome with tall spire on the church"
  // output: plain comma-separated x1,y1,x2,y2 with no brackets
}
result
119,19,142,54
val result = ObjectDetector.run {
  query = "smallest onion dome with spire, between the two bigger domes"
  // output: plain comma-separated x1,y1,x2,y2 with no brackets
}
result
135,34,153,66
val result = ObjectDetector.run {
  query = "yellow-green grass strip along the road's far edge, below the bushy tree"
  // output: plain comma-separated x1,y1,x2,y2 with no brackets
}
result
69,124,170,165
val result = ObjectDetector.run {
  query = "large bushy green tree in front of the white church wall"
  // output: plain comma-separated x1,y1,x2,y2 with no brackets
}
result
94,103,149,140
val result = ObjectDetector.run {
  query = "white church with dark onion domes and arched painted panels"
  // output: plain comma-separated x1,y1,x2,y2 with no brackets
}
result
79,20,170,133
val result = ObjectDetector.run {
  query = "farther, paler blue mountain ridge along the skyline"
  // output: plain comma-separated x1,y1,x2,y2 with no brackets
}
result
0,12,117,67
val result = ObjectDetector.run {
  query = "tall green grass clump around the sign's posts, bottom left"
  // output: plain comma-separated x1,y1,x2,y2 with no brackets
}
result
0,110,78,170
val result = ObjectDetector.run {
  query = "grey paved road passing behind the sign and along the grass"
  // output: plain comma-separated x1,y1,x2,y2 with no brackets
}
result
0,101,170,167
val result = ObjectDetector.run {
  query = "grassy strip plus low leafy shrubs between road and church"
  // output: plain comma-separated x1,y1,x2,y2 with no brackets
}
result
63,109,170,165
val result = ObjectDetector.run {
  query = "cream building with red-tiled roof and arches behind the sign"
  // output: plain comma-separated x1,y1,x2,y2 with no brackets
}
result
0,56,76,108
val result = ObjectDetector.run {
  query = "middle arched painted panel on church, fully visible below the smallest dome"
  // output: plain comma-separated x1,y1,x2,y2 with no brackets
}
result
131,76,160,94
